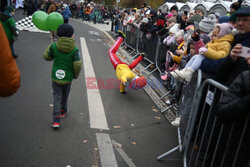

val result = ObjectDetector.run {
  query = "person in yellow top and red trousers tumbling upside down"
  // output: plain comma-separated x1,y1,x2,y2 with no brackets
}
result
109,30,147,94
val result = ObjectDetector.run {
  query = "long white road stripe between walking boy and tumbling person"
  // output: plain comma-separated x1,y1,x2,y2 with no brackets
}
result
80,37,109,130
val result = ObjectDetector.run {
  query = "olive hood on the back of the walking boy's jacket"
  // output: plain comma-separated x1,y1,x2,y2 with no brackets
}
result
56,37,76,53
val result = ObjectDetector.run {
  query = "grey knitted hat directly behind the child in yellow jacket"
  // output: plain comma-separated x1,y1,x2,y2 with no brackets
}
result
199,14,216,33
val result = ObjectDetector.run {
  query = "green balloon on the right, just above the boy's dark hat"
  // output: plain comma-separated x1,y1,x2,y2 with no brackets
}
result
47,12,63,31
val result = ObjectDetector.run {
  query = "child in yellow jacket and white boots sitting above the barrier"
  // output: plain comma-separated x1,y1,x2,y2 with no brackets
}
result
171,23,234,82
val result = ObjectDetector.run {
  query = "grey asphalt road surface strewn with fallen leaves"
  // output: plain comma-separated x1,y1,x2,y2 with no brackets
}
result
0,11,182,167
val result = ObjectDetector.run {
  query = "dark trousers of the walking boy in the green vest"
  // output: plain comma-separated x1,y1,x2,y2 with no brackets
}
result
52,81,71,117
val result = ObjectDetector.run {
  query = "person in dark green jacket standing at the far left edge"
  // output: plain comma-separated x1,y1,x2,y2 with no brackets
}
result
0,6,18,59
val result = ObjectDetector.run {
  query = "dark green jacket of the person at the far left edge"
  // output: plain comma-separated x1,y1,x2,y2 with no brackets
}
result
0,12,17,40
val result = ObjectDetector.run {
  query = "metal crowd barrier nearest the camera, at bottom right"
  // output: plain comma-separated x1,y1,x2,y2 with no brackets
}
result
157,76,250,167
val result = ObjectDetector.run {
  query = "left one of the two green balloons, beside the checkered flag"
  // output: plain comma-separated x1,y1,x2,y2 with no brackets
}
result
32,11,49,31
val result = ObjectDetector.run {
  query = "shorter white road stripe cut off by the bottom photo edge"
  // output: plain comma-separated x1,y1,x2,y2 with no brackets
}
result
96,133,118,167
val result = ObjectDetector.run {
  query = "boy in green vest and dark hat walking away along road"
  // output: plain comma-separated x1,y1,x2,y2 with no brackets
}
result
43,24,82,128
